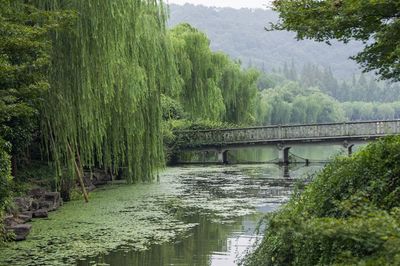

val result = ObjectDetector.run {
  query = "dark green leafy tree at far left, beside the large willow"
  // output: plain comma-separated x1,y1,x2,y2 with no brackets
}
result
0,0,71,170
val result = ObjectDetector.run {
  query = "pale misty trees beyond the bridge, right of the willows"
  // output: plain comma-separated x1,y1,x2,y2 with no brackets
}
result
256,64,400,125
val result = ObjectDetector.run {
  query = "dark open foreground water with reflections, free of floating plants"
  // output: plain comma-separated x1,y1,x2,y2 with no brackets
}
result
78,215,260,266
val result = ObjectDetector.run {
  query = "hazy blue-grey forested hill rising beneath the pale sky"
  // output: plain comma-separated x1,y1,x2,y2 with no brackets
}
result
169,4,362,79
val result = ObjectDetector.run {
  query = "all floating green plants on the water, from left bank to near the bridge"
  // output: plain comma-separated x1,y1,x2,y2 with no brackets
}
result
0,166,316,266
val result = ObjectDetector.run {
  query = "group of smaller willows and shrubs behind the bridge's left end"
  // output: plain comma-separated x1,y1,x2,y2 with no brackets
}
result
161,26,260,163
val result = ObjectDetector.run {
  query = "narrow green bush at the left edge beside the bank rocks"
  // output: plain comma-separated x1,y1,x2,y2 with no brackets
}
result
0,138,11,244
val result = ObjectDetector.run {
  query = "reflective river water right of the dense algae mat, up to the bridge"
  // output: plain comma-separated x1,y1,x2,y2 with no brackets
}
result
78,165,321,266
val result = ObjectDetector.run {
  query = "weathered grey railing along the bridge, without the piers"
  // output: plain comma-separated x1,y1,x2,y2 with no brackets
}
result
176,120,400,147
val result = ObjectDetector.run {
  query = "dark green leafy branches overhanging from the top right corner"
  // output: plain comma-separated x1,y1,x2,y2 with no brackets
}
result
271,0,400,81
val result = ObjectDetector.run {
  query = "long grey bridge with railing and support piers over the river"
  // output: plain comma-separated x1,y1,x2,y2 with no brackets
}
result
176,120,400,164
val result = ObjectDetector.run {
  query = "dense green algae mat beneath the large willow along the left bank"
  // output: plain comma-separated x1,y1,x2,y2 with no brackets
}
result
0,170,194,265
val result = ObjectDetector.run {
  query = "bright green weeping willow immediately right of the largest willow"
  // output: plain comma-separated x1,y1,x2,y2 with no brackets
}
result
169,24,225,121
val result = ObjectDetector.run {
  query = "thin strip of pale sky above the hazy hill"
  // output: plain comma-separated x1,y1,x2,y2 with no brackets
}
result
165,0,271,8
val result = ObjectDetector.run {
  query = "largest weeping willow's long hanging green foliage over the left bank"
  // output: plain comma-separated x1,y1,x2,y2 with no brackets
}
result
36,0,173,182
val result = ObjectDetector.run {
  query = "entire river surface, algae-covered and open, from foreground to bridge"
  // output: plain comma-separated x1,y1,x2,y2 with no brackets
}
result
0,145,346,266
